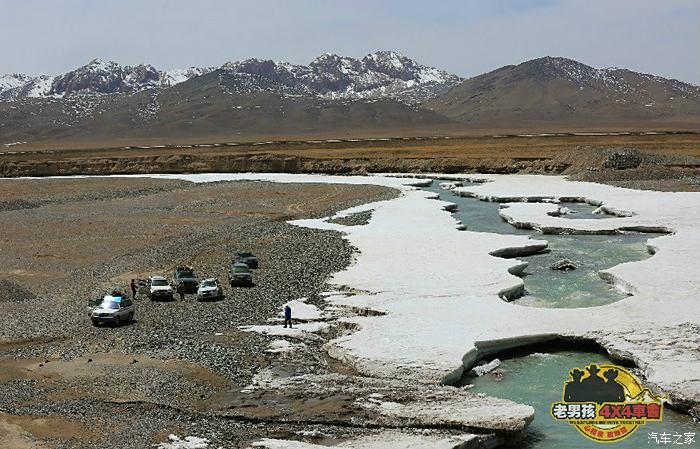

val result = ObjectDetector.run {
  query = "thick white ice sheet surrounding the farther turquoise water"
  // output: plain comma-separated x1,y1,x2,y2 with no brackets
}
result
322,175,700,400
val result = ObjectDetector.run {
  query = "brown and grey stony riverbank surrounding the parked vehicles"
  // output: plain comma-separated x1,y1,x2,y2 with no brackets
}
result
0,178,416,448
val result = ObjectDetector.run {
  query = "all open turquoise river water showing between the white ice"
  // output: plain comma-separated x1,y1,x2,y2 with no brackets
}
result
426,183,700,449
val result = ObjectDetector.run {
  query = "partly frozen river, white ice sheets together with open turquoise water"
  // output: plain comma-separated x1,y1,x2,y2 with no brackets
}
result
31,174,700,448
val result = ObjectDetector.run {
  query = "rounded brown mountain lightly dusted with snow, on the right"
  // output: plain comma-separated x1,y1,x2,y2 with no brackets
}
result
426,57,700,128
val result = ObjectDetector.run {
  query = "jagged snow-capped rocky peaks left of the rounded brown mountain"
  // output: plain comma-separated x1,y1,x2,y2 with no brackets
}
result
0,51,461,103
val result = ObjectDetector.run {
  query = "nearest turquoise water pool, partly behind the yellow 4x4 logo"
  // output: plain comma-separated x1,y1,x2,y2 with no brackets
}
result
460,351,700,449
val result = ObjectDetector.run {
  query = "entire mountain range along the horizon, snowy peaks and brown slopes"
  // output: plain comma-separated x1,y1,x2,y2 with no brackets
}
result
0,51,700,144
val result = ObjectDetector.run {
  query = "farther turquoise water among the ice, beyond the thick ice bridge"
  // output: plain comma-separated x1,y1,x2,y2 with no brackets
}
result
425,183,653,308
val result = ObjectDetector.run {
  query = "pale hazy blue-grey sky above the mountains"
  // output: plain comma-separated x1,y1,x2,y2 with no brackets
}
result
0,0,700,84
